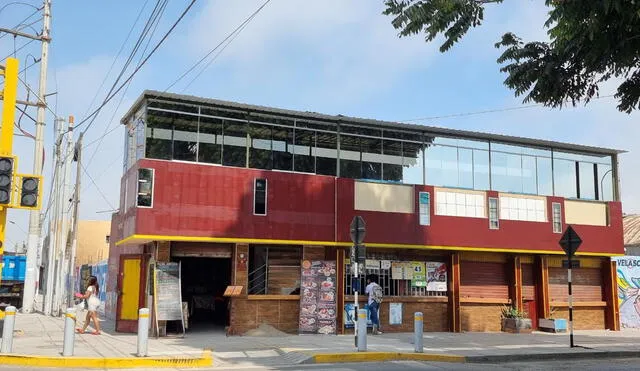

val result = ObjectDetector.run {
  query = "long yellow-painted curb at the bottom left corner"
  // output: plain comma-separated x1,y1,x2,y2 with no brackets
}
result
0,350,213,369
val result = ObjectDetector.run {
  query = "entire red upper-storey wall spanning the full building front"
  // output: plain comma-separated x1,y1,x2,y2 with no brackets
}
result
117,160,624,254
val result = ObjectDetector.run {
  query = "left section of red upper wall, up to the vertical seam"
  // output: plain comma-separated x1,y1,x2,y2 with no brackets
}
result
136,160,335,241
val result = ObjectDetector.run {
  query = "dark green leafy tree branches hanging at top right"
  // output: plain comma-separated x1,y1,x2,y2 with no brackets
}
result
384,0,640,113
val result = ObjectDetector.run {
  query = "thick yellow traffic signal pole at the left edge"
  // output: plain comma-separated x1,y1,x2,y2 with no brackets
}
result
0,58,19,288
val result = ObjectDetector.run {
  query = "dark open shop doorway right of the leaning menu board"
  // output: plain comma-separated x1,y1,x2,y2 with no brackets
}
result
173,256,231,332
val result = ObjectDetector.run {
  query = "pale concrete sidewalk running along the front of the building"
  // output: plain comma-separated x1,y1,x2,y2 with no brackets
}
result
1,314,640,368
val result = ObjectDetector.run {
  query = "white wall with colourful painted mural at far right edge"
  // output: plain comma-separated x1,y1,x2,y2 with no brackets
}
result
613,256,640,328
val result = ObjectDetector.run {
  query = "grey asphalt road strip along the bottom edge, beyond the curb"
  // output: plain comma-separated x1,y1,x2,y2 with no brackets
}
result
0,358,640,371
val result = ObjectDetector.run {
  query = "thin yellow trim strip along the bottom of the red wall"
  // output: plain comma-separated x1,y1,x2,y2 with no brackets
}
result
116,234,624,256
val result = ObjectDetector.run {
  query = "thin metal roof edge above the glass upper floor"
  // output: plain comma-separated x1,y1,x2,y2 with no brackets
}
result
121,90,626,155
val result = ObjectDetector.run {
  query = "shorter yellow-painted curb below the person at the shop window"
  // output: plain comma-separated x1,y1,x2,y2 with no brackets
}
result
305,352,466,364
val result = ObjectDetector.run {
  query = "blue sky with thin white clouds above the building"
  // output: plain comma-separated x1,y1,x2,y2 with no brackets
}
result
0,0,640,250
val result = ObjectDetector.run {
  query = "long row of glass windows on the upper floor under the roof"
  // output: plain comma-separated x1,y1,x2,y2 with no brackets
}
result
124,94,617,201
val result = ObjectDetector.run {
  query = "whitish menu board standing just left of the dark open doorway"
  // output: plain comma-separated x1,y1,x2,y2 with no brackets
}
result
154,263,182,321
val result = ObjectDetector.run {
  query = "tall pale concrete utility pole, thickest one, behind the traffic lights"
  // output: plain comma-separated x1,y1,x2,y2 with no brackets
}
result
22,0,51,313
